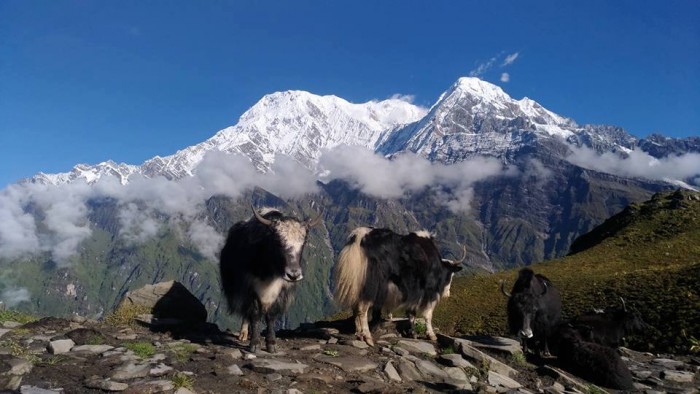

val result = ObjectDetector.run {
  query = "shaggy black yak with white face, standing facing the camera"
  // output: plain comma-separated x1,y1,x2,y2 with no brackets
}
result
219,208,321,353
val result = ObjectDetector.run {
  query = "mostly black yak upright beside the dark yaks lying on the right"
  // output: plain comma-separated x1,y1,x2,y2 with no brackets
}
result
501,268,561,355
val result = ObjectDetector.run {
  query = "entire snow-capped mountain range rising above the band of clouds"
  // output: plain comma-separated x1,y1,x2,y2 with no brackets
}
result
29,77,700,184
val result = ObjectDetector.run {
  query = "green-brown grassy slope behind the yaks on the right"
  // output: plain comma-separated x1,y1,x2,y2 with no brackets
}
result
434,192,700,352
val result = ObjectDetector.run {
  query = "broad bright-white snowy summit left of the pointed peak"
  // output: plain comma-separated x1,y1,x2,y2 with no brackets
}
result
143,91,426,178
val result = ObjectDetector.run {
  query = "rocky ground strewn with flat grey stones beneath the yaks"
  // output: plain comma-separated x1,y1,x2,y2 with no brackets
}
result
0,316,700,394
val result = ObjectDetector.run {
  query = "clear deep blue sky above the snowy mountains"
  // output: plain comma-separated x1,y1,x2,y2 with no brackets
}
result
0,0,700,189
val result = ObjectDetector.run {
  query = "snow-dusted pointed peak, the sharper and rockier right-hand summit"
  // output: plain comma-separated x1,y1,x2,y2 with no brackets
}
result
379,77,578,163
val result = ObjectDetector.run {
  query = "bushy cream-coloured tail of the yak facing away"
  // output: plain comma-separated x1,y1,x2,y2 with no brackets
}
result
333,227,372,308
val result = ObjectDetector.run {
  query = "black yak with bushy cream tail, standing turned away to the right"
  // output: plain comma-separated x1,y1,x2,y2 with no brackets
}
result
333,227,466,346
